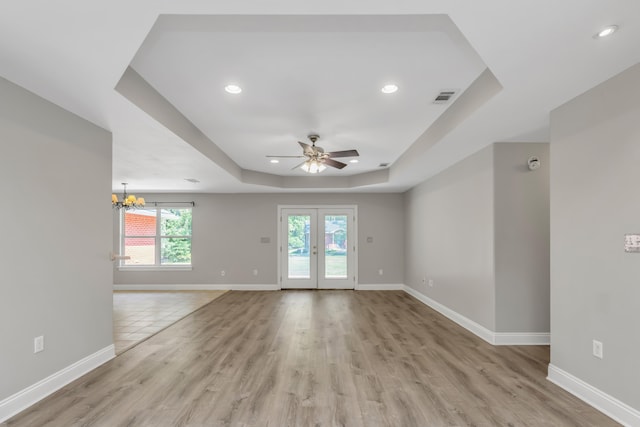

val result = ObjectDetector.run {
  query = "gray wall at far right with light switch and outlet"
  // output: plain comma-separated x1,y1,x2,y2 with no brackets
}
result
551,61,640,409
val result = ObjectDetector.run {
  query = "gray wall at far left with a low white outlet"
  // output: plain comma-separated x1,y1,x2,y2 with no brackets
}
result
0,78,113,400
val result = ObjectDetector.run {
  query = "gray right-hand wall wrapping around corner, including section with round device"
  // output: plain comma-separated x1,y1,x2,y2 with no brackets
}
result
405,143,549,333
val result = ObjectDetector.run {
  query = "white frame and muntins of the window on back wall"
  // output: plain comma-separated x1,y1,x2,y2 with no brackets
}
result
118,204,193,271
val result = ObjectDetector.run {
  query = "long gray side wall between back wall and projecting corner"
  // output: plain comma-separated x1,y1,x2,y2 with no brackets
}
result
404,145,495,331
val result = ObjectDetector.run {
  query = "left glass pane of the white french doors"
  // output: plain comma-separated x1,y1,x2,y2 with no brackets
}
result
287,215,311,279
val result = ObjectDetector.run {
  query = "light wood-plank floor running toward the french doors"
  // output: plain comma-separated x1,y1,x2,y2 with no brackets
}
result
2,291,617,427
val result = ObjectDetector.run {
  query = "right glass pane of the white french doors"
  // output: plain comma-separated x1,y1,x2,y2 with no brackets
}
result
324,215,347,279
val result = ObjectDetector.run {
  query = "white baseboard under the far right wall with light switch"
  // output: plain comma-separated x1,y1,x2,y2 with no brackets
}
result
547,363,640,427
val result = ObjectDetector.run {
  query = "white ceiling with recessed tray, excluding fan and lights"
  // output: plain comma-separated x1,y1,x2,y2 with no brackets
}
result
0,0,640,192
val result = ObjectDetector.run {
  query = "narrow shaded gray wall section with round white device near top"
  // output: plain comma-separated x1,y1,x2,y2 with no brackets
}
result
494,143,549,334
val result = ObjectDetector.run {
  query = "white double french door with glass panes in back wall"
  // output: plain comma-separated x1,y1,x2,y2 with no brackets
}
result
279,206,357,289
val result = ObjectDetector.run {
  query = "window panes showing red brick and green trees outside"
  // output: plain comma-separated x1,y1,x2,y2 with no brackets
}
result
120,207,192,267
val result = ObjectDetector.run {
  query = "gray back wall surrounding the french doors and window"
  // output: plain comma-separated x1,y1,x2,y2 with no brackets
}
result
113,193,404,284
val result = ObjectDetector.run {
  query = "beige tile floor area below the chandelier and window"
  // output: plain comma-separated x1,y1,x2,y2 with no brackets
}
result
113,291,226,354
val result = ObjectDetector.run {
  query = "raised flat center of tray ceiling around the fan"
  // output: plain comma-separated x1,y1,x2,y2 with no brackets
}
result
131,15,485,175
